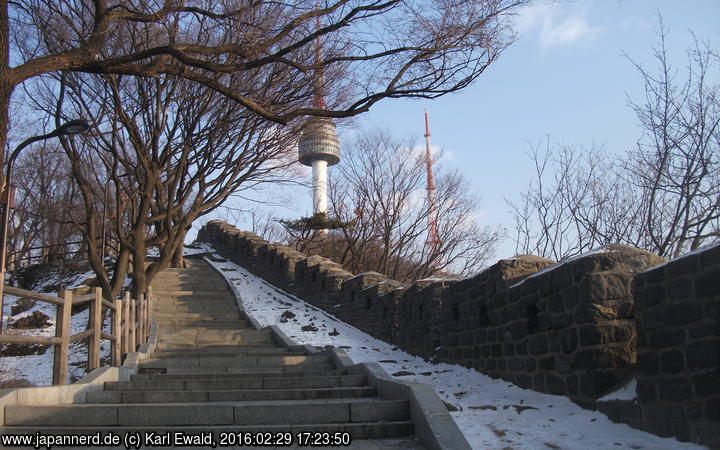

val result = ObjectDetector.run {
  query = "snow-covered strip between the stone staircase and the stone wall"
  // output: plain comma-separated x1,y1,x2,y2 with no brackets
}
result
202,250,703,450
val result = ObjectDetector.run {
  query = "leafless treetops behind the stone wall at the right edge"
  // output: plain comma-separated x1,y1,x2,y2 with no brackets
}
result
510,23,720,259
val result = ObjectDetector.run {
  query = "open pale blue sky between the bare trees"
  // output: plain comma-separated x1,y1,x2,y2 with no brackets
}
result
205,0,720,258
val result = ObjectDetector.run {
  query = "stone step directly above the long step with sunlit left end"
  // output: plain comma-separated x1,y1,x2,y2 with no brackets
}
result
87,386,376,403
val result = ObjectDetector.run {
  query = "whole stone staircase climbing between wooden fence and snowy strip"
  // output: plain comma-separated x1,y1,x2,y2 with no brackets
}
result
3,259,423,449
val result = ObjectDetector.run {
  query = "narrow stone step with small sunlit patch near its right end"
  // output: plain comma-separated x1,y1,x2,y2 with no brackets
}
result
140,356,332,368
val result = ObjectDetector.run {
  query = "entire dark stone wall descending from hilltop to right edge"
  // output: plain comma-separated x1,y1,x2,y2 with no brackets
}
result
198,221,720,442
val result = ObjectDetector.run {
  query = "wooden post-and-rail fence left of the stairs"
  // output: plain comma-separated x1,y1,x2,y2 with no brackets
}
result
0,286,154,385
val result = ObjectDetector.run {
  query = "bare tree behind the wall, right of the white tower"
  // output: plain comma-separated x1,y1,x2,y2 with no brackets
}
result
310,127,501,281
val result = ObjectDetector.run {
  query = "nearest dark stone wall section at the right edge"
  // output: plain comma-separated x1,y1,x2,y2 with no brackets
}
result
634,245,720,448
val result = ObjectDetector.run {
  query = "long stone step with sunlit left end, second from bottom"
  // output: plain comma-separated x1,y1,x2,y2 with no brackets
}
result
5,398,409,427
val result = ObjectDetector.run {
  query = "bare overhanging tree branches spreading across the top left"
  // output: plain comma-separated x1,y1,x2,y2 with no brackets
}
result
0,0,527,165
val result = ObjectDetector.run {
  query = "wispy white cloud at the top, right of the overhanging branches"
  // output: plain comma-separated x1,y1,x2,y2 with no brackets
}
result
515,2,602,51
